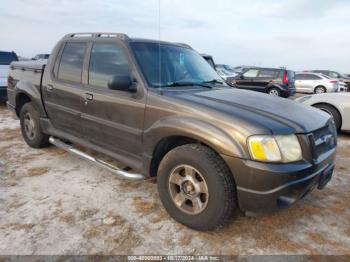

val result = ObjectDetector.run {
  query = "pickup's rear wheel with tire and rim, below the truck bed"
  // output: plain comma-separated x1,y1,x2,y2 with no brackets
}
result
20,103,49,148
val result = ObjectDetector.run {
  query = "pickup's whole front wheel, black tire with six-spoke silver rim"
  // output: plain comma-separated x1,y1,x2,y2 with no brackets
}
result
157,144,238,230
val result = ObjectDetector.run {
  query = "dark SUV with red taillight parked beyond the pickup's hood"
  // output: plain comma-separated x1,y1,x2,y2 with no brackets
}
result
230,67,296,97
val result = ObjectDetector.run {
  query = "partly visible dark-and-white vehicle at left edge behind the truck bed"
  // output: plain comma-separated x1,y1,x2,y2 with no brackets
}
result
0,51,18,102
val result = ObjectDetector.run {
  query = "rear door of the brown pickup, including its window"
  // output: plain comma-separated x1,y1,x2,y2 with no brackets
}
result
42,41,87,137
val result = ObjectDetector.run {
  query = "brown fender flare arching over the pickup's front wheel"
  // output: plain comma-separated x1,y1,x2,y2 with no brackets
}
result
144,116,248,158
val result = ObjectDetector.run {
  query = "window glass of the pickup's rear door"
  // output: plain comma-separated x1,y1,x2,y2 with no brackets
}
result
57,42,86,83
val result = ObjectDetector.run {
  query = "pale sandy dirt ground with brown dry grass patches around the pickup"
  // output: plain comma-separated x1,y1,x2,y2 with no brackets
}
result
0,105,350,255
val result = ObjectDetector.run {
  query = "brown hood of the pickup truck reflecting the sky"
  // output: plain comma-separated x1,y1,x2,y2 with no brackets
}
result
172,88,330,134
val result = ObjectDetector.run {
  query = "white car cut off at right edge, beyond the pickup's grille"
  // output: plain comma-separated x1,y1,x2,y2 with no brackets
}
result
295,93,350,132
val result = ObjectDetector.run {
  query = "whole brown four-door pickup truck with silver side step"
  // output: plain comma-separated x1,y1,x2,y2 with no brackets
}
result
8,33,336,230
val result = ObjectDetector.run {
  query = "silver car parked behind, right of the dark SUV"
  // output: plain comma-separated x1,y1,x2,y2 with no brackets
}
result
295,72,340,94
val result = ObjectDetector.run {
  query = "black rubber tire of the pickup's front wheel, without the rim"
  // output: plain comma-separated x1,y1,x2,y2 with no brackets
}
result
157,144,238,231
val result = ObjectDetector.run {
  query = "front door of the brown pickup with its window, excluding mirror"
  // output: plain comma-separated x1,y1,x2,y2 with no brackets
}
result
82,40,146,163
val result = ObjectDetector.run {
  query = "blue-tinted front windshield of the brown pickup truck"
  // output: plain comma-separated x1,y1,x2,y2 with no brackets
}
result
131,42,222,87
